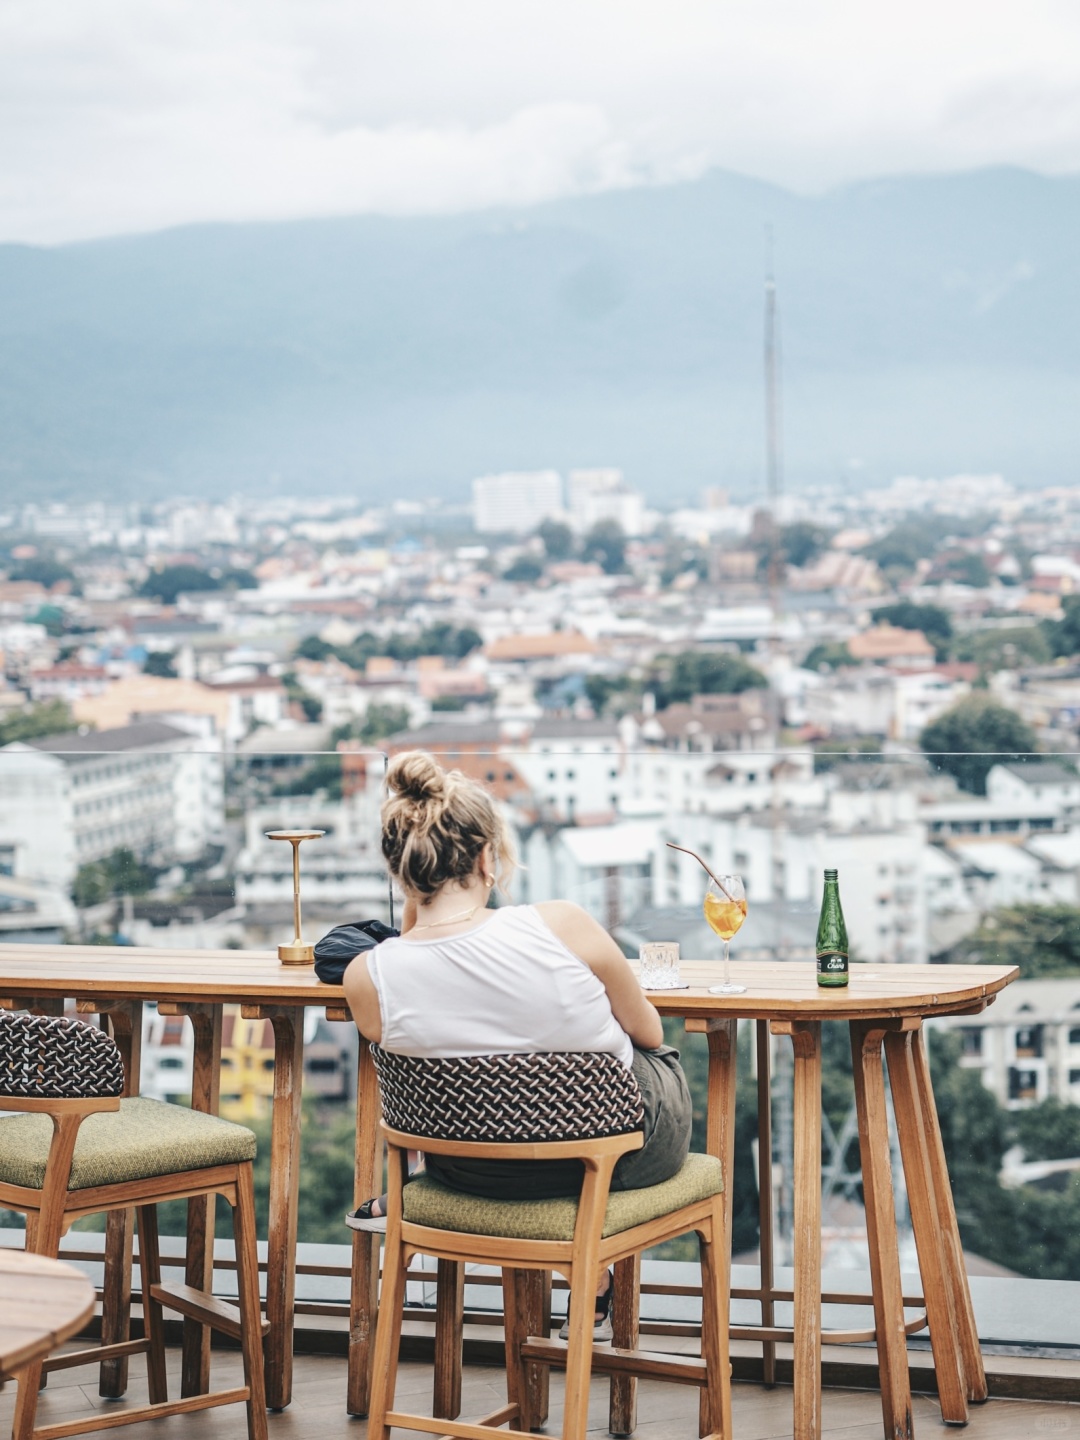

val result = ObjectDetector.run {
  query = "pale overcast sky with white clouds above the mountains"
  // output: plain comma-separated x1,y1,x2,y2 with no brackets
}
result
0,0,1080,243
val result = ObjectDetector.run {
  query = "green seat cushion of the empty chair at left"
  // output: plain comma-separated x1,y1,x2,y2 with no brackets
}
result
0,1097,255,1189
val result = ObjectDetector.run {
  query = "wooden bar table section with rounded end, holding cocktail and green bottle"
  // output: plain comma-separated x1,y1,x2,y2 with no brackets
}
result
642,960,1018,1440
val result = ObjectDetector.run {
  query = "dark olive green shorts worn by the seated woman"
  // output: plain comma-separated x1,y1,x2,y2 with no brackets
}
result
428,1045,693,1200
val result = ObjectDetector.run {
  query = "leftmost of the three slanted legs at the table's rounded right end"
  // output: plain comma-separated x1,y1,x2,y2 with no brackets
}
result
852,1020,913,1440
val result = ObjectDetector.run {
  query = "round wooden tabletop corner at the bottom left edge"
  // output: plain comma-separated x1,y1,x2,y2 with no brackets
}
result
0,1250,95,1382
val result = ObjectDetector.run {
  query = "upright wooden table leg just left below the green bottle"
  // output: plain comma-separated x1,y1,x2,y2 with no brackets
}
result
772,1020,823,1440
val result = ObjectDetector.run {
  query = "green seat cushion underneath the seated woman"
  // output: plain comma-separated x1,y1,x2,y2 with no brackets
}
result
403,1155,724,1240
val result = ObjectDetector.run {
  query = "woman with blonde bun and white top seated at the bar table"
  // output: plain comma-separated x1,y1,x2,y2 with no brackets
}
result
344,750,691,1338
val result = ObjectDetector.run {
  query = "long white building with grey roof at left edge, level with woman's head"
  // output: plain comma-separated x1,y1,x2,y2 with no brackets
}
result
0,720,225,890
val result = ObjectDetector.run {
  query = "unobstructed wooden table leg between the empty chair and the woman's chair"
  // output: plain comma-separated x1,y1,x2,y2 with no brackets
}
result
263,1005,304,1410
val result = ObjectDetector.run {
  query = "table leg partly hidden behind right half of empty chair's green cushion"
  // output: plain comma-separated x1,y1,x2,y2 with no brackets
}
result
169,1002,223,1397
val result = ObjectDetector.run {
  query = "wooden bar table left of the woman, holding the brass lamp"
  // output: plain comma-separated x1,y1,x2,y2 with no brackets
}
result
0,945,351,1410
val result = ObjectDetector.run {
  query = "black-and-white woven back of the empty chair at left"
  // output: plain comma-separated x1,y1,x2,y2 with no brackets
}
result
0,1011,124,1100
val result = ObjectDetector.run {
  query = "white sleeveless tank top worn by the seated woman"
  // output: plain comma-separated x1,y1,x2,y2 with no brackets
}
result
367,904,634,1068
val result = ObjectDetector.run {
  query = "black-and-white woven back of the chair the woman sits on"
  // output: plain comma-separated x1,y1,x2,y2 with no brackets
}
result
372,1044,644,1143
